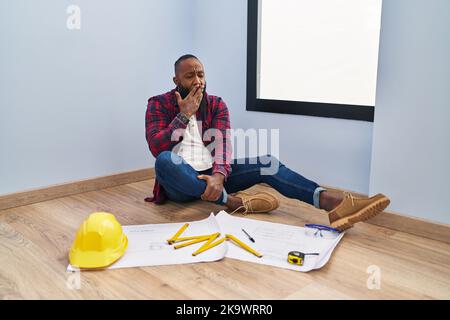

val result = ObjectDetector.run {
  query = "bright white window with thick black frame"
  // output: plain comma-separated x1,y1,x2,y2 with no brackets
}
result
247,0,382,121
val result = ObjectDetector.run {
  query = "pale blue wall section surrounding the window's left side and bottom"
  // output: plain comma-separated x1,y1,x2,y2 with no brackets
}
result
194,0,373,193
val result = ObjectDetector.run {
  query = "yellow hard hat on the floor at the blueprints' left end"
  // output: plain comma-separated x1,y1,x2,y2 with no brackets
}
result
69,212,128,268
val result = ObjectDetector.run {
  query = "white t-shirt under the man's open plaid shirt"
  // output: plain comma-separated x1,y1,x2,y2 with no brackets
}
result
176,114,213,171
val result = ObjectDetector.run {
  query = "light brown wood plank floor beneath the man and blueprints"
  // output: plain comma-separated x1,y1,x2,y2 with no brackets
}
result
0,180,450,299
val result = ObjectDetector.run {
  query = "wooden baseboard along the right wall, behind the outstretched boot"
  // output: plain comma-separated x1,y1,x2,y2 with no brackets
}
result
325,186,450,243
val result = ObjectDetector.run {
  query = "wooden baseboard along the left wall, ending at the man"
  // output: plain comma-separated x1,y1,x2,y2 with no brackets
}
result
0,168,155,210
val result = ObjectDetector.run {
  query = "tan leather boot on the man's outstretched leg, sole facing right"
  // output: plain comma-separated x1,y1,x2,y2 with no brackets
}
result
328,193,391,231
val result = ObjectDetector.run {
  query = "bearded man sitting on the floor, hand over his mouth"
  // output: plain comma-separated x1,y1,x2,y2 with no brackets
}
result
145,55,390,231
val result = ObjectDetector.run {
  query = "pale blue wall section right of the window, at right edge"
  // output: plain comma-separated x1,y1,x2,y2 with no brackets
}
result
370,0,450,224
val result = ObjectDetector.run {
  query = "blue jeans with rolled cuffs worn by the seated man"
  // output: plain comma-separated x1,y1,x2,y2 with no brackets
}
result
155,151,325,208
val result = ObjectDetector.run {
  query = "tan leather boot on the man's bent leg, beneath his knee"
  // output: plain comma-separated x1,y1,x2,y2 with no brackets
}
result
230,191,280,215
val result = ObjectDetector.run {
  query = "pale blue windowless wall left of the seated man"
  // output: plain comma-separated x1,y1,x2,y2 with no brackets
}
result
0,0,194,194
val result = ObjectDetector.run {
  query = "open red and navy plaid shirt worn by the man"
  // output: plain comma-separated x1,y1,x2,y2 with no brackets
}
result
145,89,232,204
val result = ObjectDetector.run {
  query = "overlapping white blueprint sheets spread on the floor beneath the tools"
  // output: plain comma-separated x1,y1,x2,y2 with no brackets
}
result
67,210,344,272
